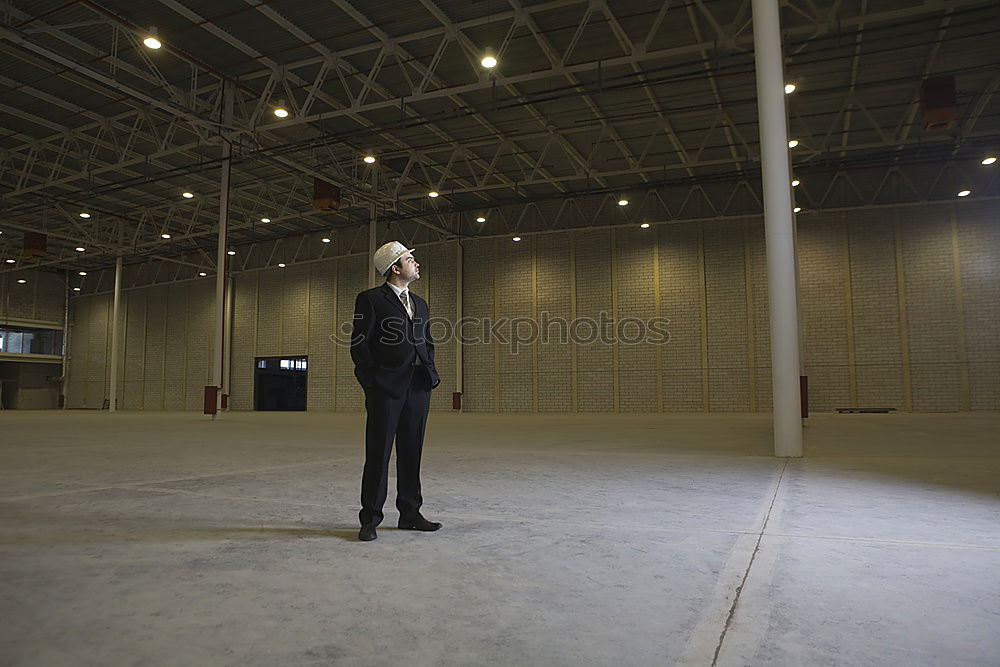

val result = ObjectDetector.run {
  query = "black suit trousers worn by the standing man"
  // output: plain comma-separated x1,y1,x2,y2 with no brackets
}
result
358,366,431,526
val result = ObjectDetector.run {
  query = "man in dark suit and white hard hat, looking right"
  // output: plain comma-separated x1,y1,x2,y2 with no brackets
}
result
351,241,441,542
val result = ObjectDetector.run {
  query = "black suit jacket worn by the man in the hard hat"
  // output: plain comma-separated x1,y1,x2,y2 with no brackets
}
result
351,283,441,398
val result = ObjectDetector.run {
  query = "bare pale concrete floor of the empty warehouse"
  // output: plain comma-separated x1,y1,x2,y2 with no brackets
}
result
0,411,1000,667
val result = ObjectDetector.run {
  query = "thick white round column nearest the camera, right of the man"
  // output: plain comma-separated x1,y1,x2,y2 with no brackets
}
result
753,0,802,456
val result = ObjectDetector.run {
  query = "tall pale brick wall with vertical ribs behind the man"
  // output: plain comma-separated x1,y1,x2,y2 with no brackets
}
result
64,202,1000,412
